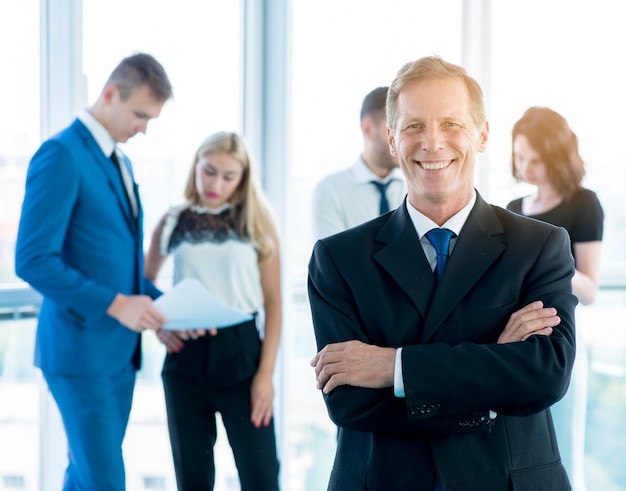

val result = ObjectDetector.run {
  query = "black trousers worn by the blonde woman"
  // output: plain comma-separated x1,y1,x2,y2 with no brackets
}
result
161,321,279,491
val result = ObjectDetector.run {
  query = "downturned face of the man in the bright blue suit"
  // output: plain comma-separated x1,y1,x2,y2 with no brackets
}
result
105,85,164,143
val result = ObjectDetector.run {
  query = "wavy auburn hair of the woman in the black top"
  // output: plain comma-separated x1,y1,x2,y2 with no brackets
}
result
511,107,585,200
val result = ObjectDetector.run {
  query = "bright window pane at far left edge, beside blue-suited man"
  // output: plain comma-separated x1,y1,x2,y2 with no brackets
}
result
0,0,40,491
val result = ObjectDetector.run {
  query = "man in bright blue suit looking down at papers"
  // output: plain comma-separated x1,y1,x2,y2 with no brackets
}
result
15,53,172,491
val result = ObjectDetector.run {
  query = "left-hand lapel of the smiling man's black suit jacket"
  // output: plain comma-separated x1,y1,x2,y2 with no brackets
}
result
373,204,435,317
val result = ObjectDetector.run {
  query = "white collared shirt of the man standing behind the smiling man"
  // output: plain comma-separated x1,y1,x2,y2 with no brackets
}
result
312,157,406,240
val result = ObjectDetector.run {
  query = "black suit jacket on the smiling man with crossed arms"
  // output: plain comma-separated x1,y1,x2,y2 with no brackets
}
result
309,196,576,491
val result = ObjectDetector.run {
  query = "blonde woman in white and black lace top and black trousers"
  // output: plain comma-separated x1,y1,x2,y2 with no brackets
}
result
145,132,282,491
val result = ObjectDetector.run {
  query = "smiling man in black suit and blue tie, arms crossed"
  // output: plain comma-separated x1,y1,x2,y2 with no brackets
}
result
309,57,576,491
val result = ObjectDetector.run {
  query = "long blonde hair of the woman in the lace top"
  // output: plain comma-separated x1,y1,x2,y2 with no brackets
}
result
184,131,277,262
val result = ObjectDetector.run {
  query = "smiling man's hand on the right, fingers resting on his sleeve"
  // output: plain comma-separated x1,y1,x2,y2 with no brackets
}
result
498,301,561,344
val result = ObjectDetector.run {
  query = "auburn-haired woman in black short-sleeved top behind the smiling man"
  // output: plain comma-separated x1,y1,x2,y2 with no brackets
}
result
507,107,604,491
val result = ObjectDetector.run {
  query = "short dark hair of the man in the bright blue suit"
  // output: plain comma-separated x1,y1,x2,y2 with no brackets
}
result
107,53,173,102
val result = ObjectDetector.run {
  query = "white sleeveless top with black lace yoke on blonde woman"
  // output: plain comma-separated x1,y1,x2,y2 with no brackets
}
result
160,204,263,313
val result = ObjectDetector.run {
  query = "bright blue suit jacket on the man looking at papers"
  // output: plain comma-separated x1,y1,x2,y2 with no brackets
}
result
15,120,160,375
